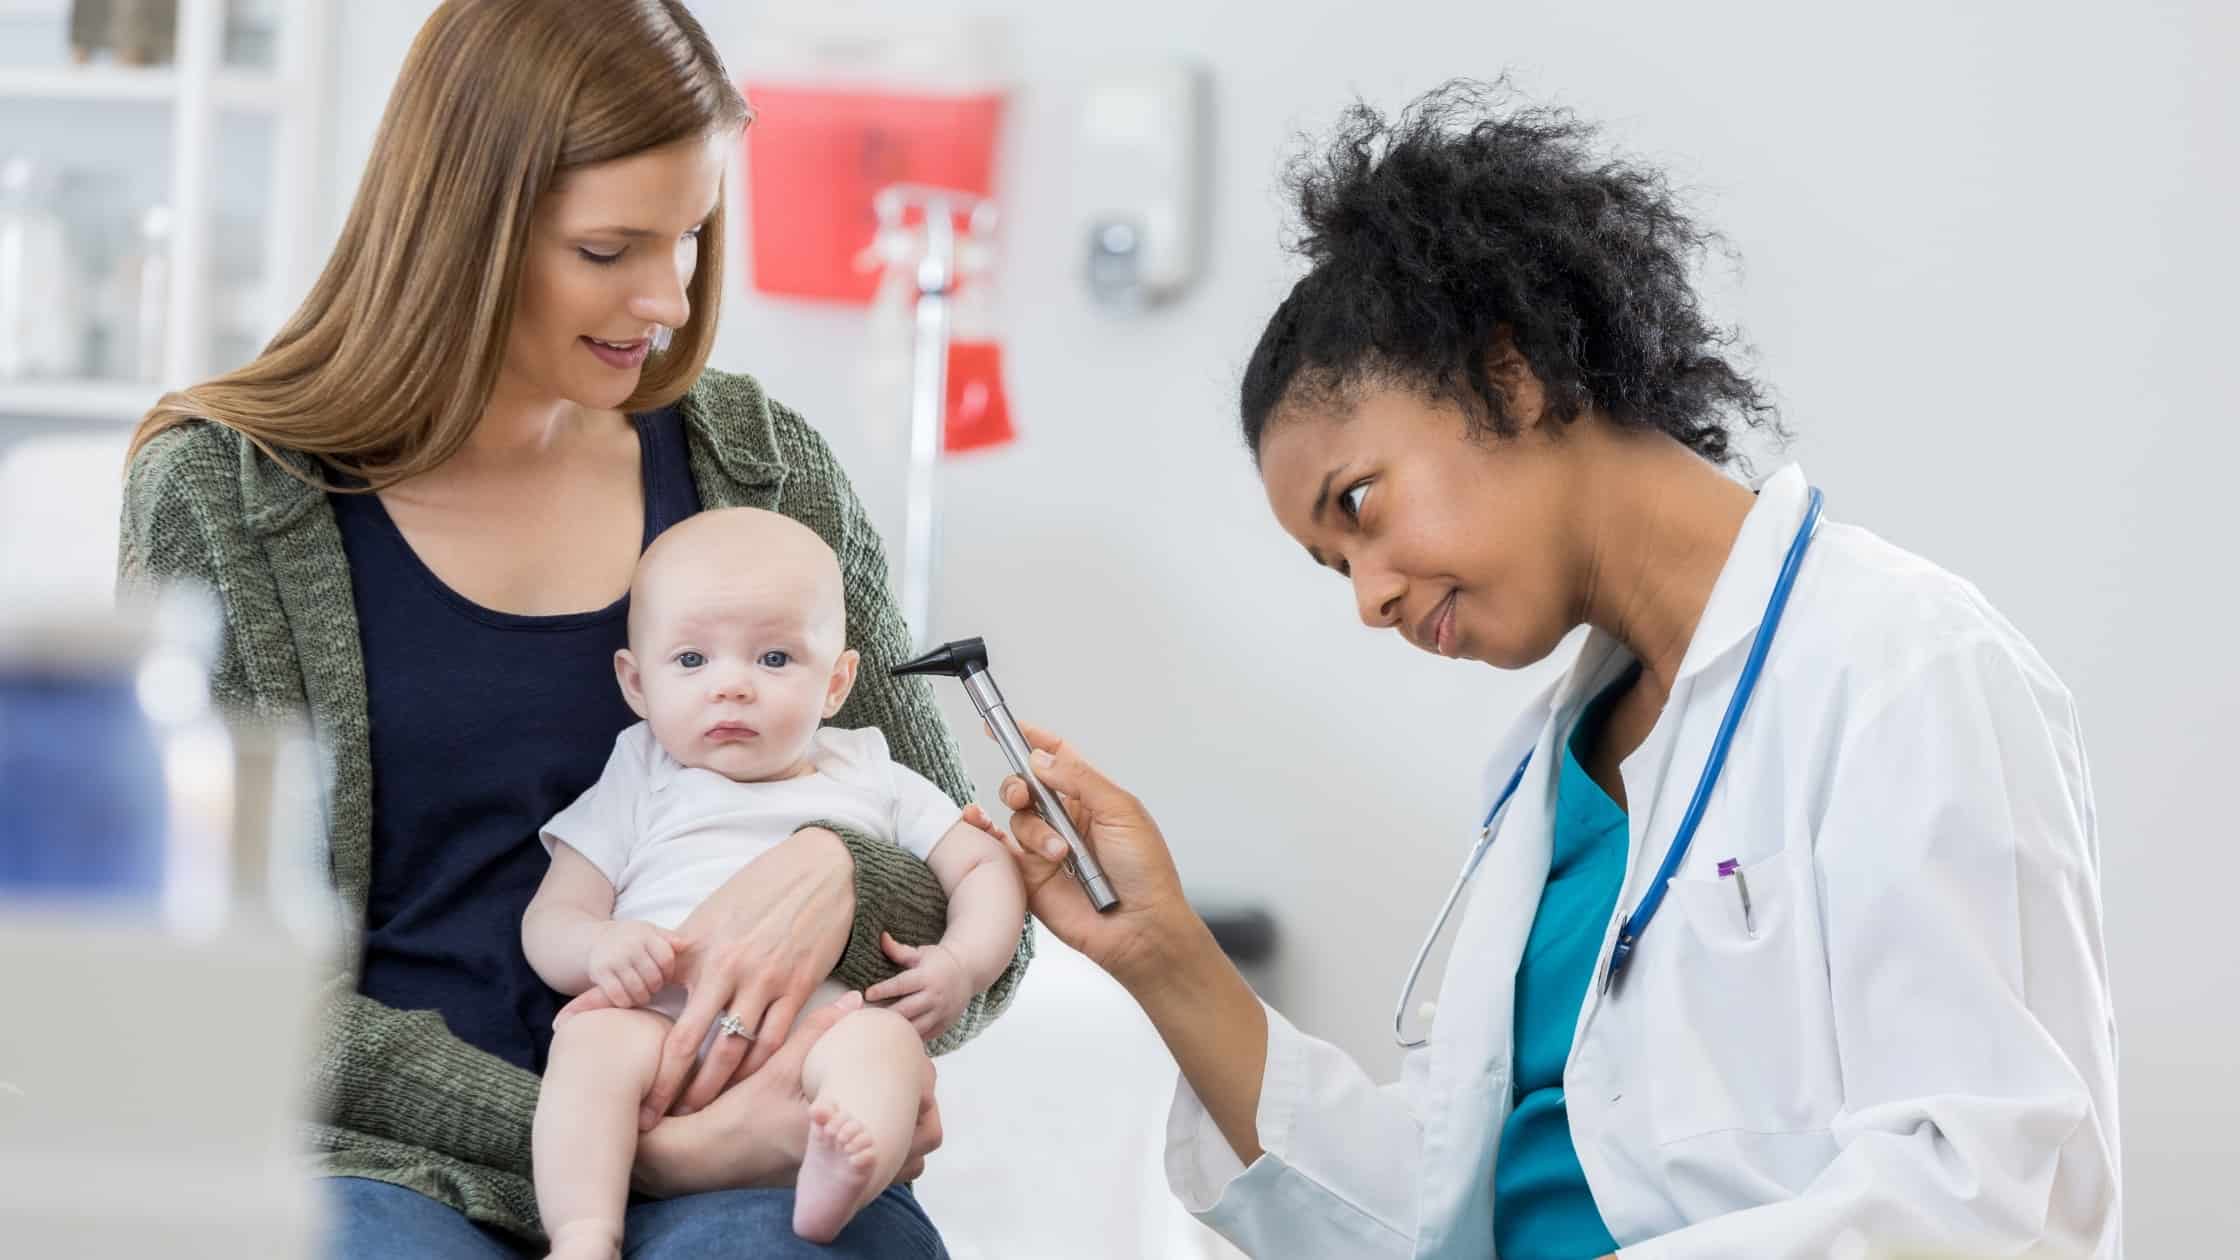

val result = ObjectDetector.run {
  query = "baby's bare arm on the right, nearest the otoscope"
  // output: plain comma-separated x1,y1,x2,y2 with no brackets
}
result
865,823,1026,1040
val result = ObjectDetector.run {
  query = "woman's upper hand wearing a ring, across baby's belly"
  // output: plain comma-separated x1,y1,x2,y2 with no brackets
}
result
638,827,856,1130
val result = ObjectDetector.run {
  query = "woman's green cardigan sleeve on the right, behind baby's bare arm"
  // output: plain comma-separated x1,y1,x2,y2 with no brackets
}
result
771,404,1035,1054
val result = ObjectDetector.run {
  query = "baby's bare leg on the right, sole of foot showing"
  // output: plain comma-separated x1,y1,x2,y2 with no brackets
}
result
793,1007,925,1242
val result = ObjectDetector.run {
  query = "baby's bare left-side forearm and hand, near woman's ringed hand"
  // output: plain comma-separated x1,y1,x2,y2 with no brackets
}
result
522,841,676,1007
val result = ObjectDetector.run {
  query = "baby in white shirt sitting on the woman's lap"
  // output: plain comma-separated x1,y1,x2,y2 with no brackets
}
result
522,509,1026,1256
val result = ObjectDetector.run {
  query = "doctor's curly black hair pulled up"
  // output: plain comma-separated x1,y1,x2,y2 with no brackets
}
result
1239,78,1781,464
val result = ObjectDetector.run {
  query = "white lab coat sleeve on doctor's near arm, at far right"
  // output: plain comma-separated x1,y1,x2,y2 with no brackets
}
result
1622,634,2121,1260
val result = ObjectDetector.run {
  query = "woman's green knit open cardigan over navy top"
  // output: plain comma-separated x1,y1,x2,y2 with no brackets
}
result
116,372,1033,1238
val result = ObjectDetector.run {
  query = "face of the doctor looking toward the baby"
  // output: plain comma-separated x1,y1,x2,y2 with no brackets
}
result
1259,386,1597,668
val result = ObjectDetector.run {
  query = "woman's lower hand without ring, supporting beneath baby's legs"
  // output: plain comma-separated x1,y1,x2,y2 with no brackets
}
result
629,993,941,1199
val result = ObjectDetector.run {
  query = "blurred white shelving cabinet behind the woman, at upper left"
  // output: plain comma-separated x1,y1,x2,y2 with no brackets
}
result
0,0,334,425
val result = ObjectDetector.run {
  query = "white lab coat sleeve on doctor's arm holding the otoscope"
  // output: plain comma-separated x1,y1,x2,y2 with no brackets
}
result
1167,995,1427,1260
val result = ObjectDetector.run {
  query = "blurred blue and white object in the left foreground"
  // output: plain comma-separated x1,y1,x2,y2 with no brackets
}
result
0,430,340,1258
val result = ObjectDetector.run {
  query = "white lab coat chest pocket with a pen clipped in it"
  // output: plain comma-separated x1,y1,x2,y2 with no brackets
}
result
1642,850,1837,1141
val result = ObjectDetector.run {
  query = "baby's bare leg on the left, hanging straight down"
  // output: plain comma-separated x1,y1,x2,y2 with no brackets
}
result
531,1009,670,1258
